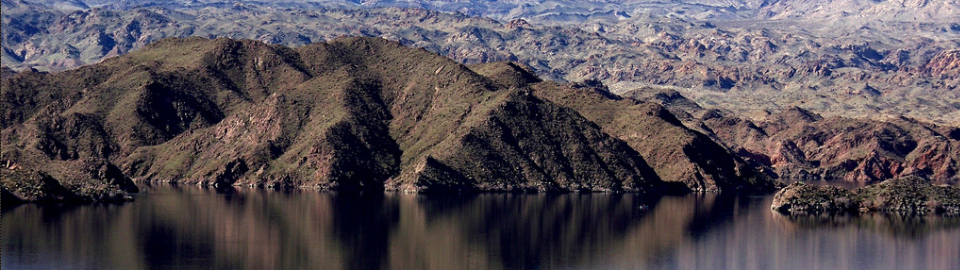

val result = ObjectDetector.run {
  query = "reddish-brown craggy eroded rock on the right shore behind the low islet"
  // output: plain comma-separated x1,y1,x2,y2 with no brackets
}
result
732,109,960,185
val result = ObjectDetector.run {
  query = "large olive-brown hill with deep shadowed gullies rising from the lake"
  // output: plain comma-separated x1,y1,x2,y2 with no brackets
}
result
0,38,775,200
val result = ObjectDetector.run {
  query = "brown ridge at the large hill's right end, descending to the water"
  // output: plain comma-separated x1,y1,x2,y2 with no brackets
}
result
533,82,775,190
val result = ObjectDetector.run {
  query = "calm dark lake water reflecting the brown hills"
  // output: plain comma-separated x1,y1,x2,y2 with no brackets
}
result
0,186,960,270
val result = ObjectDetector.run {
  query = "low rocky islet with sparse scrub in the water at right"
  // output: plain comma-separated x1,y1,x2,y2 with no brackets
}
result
771,177,960,215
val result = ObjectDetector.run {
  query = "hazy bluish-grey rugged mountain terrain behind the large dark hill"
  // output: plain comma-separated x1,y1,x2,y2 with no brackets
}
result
2,0,960,126
